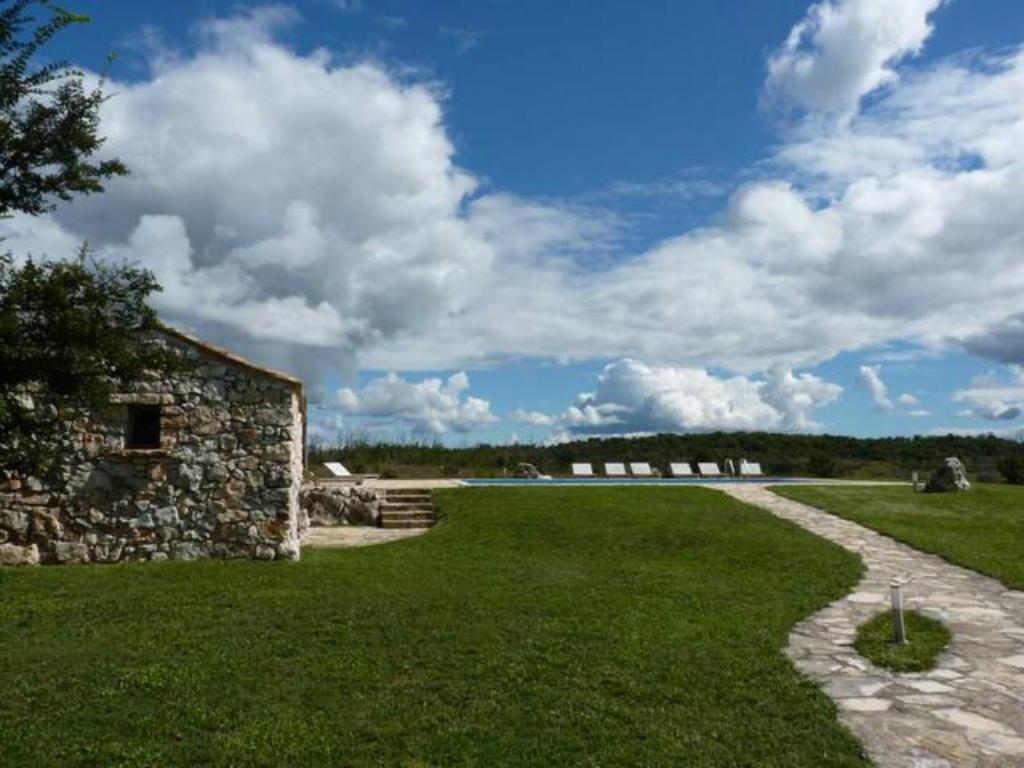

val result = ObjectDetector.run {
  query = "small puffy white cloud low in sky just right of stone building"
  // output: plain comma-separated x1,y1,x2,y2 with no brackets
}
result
336,372,498,436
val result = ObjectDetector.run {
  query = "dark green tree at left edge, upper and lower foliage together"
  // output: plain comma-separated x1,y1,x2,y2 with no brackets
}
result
0,0,163,473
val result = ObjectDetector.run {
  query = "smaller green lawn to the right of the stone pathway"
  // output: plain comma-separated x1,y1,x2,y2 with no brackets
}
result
772,485,1024,589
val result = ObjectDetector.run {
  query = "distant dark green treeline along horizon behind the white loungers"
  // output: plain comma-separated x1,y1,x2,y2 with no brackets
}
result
309,432,1024,481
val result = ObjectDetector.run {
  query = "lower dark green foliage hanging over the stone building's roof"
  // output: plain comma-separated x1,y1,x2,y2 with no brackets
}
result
0,248,167,472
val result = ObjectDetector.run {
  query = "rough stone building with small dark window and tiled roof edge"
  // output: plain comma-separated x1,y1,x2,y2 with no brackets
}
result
0,329,305,564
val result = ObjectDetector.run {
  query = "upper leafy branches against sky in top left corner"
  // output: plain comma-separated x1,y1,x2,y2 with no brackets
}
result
0,0,128,216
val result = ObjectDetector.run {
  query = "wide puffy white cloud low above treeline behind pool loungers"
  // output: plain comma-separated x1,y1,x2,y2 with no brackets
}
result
524,359,843,436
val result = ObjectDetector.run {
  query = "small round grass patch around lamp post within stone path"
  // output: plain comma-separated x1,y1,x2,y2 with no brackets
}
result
854,610,952,672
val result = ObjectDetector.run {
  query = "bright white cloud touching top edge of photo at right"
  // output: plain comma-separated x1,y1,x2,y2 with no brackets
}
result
766,0,942,114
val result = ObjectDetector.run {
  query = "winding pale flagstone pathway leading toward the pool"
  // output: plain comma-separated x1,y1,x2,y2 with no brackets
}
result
719,484,1024,768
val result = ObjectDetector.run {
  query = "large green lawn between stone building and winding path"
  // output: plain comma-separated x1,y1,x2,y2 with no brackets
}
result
0,488,868,768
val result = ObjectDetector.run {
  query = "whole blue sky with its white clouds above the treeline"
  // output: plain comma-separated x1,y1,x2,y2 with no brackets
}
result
14,0,1024,443
